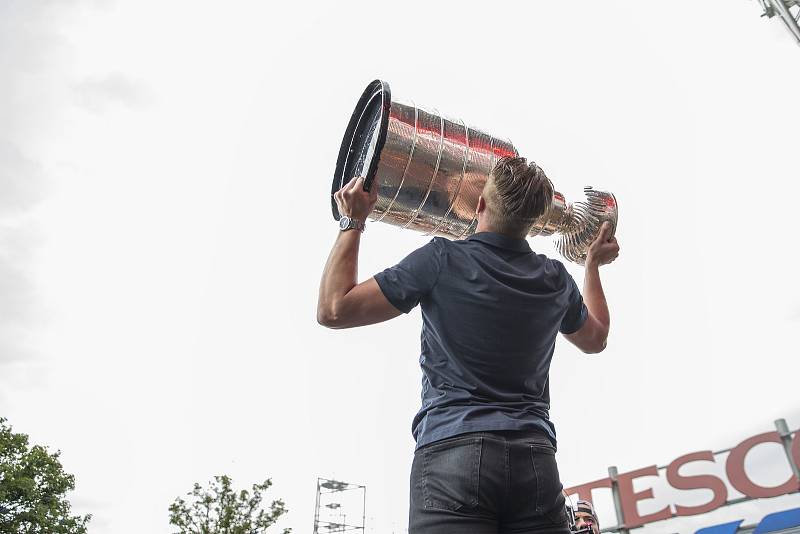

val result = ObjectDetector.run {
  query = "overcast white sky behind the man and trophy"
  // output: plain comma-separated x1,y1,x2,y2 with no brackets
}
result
0,0,800,534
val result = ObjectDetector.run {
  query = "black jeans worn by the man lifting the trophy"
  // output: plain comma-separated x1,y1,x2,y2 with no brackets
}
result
408,432,570,534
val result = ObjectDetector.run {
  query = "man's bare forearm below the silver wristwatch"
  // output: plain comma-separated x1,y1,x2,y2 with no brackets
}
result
317,230,361,323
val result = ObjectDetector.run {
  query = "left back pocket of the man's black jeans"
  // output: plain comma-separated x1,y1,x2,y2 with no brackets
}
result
422,436,483,511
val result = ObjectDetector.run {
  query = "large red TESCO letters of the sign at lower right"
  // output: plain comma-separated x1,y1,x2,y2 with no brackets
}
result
566,432,800,528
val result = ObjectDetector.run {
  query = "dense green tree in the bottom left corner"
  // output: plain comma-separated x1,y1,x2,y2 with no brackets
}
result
0,418,91,534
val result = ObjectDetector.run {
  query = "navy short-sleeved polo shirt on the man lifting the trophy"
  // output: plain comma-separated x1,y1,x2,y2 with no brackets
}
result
375,232,587,448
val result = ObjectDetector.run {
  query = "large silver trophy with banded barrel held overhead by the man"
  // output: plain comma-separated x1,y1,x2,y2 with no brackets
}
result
331,80,617,265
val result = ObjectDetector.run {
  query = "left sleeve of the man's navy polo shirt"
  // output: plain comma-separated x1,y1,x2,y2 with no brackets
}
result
375,238,443,313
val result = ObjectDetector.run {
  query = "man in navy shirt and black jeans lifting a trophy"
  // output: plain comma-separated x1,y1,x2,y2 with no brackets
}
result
317,158,619,534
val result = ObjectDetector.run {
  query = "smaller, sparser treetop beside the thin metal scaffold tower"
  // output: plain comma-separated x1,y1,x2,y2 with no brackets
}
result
169,475,291,534
